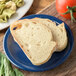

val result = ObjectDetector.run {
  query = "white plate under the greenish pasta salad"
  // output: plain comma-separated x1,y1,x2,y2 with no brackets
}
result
0,0,33,30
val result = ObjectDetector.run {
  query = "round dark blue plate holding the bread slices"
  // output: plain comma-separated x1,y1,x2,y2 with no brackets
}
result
3,14,74,72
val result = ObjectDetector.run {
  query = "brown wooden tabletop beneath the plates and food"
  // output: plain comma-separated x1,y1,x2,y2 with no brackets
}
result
0,0,76,76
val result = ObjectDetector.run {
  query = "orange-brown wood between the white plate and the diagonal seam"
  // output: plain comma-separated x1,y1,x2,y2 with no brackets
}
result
25,0,55,16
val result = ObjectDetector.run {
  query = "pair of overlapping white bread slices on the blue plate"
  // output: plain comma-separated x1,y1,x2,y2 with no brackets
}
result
10,18,67,65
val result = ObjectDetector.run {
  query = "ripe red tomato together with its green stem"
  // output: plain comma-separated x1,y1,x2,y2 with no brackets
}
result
56,0,76,22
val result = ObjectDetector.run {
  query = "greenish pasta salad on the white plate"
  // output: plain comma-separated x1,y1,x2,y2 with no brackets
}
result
0,0,24,23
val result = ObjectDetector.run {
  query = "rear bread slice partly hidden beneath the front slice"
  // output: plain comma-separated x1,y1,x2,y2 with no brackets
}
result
32,18,67,52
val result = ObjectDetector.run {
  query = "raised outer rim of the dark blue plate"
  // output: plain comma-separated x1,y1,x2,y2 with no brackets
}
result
3,14,74,72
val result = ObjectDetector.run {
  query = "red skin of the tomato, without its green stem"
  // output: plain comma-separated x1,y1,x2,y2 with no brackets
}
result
56,0,76,19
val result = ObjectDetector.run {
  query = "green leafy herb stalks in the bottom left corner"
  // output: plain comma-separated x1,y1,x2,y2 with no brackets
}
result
0,52,24,76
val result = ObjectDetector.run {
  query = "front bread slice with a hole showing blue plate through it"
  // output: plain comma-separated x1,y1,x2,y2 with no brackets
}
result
10,19,56,65
